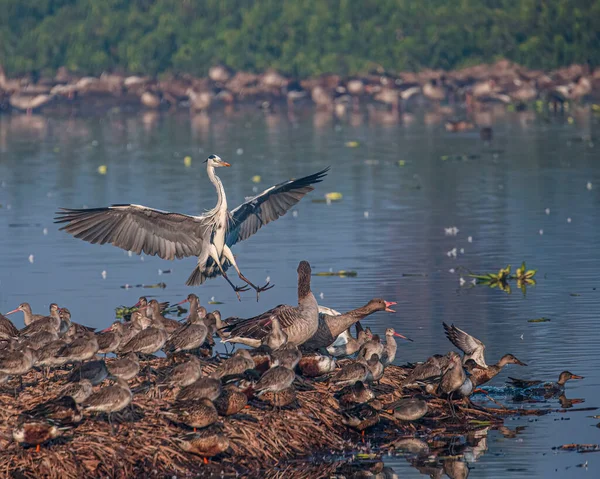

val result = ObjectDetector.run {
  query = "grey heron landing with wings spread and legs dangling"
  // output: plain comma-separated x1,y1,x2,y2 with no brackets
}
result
54,155,329,301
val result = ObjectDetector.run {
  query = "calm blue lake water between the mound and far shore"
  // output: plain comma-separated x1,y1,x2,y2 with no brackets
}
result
0,110,600,478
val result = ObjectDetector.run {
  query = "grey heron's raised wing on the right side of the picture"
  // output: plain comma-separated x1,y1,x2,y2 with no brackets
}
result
225,167,329,246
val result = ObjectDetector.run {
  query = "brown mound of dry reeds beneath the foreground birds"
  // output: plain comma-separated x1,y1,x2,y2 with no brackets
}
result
0,358,520,478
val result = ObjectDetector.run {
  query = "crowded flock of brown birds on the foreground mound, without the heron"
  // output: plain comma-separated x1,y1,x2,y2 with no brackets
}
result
0,261,581,458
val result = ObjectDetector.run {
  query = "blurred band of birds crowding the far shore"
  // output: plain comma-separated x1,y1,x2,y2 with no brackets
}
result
0,60,600,114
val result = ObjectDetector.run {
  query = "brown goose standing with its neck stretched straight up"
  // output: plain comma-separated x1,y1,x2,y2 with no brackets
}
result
224,261,319,347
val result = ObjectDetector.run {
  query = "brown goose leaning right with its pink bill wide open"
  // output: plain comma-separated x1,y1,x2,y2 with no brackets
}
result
303,298,396,349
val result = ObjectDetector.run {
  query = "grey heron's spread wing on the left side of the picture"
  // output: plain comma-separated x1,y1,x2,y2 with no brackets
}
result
54,205,211,259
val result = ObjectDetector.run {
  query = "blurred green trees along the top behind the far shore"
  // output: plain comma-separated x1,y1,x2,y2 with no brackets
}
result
0,0,600,76
